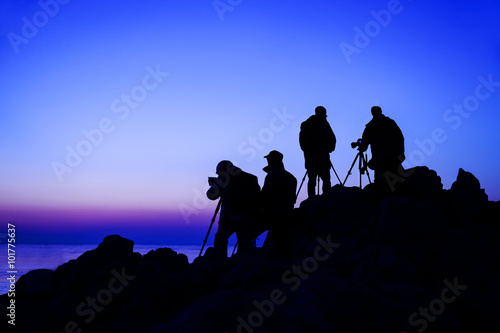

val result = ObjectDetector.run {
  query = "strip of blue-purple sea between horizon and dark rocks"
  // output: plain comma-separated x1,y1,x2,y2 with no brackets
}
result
0,244,232,295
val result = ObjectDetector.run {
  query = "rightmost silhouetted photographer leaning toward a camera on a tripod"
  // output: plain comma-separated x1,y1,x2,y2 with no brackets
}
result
358,106,405,197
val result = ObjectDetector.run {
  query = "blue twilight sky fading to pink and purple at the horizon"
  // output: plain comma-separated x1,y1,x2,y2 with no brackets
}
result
0,0,500,244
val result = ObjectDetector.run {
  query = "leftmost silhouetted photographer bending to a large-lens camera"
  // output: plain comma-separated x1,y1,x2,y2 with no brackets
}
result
207,161,260,256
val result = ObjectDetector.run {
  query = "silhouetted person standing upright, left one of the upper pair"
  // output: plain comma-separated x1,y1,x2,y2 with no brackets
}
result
299,106,337,197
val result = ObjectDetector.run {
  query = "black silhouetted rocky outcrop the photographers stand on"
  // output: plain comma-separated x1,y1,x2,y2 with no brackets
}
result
0,167,500,333
